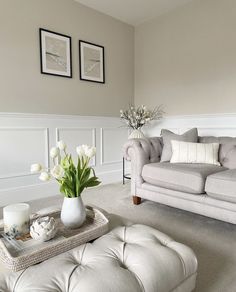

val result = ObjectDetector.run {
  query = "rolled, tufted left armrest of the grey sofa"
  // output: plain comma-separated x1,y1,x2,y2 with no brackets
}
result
123,137,162,195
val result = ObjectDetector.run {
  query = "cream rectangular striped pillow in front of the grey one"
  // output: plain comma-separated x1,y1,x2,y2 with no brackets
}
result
170,140,220,165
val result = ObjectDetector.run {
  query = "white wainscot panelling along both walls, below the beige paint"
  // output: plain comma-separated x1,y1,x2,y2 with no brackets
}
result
0,113,236,205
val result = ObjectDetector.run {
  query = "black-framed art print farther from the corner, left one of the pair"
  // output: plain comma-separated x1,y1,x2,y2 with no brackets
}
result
39,28,72,78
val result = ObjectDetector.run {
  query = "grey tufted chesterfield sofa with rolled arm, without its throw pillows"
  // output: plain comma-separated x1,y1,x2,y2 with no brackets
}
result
124,137,236,224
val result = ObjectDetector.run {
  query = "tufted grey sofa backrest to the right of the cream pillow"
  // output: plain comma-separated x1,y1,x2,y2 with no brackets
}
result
199,136,236,169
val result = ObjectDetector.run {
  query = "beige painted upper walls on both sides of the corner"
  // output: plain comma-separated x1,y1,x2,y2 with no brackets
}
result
0,0,236,116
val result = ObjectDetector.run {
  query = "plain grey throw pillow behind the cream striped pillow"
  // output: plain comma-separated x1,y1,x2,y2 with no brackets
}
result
161,128,198,162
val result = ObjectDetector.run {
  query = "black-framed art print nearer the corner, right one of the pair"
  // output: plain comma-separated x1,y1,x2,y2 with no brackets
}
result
79,40,105,83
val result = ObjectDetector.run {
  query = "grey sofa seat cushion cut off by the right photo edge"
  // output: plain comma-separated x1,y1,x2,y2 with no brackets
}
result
205,169,236,203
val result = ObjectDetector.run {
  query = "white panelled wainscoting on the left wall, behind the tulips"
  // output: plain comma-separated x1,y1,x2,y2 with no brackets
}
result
0,113,129,206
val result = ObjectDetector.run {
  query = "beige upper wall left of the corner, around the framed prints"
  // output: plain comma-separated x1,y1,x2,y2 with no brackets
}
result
0,0,134,116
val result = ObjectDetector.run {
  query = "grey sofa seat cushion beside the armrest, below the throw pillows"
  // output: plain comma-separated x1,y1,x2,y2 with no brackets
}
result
142,162,225,194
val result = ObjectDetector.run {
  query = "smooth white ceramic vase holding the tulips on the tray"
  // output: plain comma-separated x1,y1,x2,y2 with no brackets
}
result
61,197,86,229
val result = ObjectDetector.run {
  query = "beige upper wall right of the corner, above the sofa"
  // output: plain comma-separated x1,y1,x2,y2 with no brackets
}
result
135,0,236,114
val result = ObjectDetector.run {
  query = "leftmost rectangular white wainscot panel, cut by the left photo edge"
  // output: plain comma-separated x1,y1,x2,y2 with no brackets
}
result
0,127,49,179
